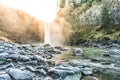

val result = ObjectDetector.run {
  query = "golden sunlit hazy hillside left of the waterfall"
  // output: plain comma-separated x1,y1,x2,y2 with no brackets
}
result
0,5,43,43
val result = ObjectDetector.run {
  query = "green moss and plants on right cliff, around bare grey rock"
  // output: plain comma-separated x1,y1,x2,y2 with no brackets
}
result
58,0,120,45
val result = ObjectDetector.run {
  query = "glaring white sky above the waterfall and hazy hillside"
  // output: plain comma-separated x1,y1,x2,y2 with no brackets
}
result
0,0,57,22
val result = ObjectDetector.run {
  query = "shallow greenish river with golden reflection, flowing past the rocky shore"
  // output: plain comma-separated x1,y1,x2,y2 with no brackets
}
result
53,47,120,80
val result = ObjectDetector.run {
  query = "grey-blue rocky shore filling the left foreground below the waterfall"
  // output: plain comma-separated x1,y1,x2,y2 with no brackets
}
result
0,41,86,80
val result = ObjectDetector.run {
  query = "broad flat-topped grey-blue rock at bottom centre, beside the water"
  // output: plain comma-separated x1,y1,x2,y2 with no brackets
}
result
48,66,81,80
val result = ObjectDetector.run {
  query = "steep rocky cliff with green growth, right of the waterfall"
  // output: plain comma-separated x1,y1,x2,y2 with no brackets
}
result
58,0,120,43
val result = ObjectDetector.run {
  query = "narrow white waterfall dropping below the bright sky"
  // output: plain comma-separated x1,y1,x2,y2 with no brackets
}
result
44,22,50,44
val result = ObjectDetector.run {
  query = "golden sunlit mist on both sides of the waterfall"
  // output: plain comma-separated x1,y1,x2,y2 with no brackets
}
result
0,5,71,45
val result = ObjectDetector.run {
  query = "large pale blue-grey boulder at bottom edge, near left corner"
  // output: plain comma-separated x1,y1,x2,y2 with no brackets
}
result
8,68,33,80
